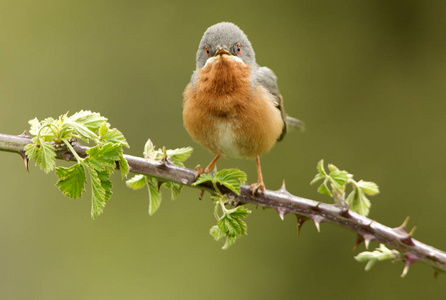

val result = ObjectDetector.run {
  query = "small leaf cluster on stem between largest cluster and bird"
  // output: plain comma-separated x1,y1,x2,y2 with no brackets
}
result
126,139,192,215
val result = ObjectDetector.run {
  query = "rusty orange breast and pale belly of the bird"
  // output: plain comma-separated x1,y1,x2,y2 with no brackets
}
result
183,56,283,157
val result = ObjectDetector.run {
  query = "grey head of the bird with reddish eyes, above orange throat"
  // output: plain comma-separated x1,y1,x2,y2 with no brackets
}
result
196,22,257,69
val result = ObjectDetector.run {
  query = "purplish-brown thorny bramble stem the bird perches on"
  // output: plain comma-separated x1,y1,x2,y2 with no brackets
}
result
0,134,446,274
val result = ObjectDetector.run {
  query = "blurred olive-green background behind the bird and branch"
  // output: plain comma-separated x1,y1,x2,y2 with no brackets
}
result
0,0,446,299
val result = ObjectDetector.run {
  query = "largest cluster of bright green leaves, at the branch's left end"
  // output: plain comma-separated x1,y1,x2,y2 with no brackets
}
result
24,110,129,218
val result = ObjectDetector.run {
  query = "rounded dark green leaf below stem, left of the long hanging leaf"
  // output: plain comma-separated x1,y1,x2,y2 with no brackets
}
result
56,164,86,199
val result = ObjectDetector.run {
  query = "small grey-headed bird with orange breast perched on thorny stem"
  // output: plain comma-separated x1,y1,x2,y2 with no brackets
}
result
183,22,303,192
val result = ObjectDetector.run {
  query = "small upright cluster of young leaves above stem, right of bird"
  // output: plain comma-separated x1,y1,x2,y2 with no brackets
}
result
311,160,379,216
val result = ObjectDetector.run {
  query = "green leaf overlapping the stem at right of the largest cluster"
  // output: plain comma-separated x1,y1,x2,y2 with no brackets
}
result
85,143,122,172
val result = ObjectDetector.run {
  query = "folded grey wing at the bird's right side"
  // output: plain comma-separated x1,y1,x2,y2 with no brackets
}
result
254,67,287,141
